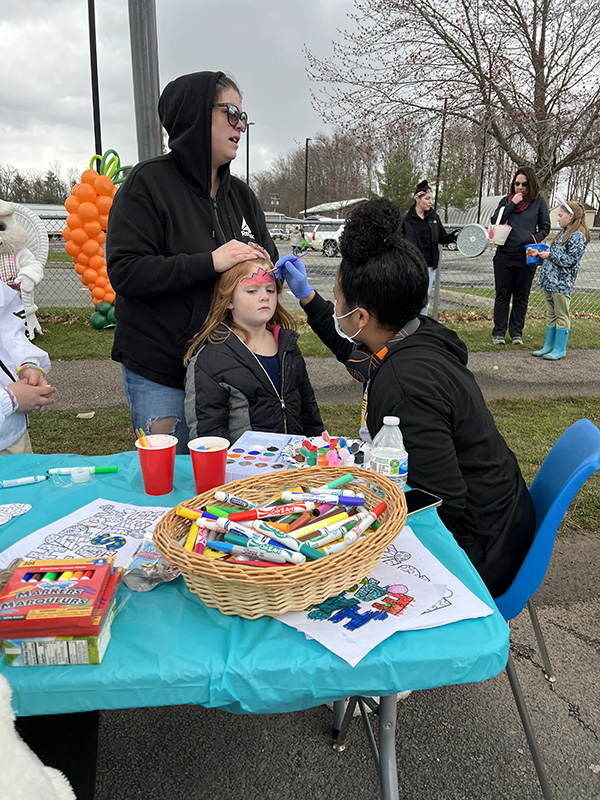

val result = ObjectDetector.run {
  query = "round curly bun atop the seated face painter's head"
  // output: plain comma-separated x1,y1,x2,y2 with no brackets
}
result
340,197,402,264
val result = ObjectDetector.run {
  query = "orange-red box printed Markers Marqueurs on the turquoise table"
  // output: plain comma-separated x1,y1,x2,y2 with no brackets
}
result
0,558,114,638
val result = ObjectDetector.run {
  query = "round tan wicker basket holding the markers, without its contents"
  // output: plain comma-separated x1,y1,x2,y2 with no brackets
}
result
154,467,406,619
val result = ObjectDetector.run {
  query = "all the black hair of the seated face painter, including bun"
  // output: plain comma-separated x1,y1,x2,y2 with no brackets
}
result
337,197,429,331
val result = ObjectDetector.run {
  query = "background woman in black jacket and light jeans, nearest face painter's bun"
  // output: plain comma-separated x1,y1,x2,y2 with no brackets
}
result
402,180,458,314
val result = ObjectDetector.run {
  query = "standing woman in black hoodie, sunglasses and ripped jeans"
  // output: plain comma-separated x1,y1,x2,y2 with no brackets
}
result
107,72,277,452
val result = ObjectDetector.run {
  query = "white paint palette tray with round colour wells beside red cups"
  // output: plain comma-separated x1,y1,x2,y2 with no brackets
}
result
225,431,304,483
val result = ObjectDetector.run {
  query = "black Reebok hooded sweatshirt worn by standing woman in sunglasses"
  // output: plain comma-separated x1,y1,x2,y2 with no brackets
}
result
106,72,278,389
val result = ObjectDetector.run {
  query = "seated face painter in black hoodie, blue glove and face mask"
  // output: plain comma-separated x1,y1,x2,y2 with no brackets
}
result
276,199,535,596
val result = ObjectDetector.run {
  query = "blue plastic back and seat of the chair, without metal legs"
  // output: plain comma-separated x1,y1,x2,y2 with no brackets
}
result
494,419,600,621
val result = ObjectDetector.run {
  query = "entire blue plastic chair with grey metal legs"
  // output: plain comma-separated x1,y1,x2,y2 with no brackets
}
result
494,419,600,800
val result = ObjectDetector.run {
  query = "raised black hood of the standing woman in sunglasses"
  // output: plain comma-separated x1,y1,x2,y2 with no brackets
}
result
158,72,229,196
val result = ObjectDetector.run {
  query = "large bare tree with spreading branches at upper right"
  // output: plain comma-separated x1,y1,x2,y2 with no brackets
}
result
307,0,600,192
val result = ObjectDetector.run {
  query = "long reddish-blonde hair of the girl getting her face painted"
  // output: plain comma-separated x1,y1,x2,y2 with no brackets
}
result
183,258,296,367
